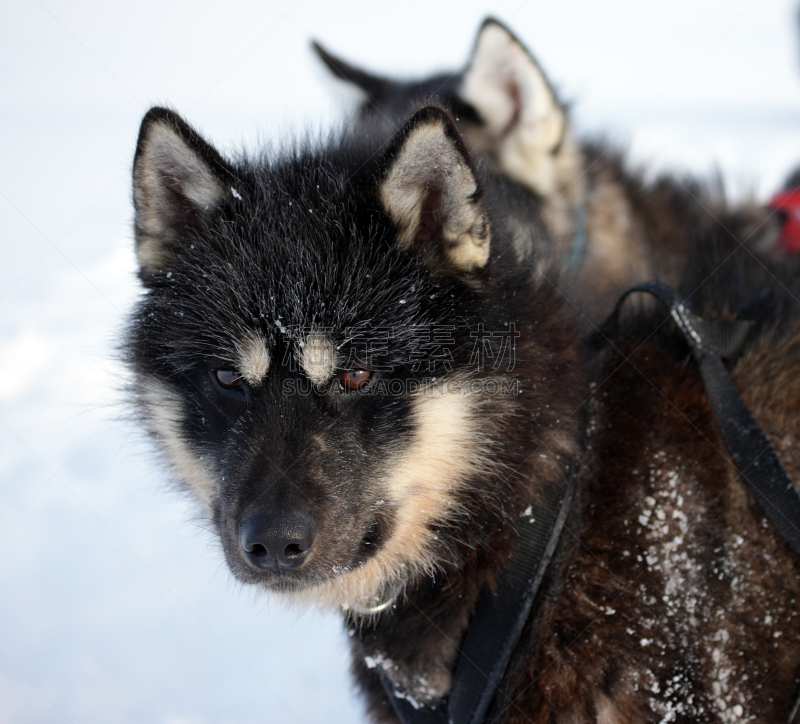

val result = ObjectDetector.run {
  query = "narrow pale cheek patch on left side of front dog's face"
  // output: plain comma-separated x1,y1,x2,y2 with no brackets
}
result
140,378,215,508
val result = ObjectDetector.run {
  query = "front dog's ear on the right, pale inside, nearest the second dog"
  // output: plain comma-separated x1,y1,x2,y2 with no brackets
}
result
378,106,489,273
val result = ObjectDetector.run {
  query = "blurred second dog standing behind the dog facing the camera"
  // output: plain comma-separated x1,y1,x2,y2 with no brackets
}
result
314,18,781,323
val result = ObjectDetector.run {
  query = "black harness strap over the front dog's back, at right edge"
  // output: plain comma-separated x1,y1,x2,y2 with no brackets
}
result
609,282,800,555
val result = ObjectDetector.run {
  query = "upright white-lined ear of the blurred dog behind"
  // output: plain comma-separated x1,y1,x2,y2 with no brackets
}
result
460,18,567,161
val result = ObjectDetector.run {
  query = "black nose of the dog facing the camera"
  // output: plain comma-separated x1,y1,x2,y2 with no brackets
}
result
239,508,317,573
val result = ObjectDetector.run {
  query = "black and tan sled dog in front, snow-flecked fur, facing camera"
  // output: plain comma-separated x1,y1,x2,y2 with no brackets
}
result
125,106,800,724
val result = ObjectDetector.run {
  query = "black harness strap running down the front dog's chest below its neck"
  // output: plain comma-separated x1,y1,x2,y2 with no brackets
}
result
381,468,578,724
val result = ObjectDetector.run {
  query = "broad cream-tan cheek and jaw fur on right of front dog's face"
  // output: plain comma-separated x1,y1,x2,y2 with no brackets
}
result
309,388,491,607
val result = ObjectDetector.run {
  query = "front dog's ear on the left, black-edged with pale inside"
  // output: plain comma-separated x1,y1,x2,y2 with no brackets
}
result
133,108,233,279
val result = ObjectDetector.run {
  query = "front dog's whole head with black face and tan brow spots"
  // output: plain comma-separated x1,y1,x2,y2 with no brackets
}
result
126,107,528,606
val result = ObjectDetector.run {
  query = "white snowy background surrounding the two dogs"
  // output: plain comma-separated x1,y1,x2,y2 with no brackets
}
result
0,0,800,724
